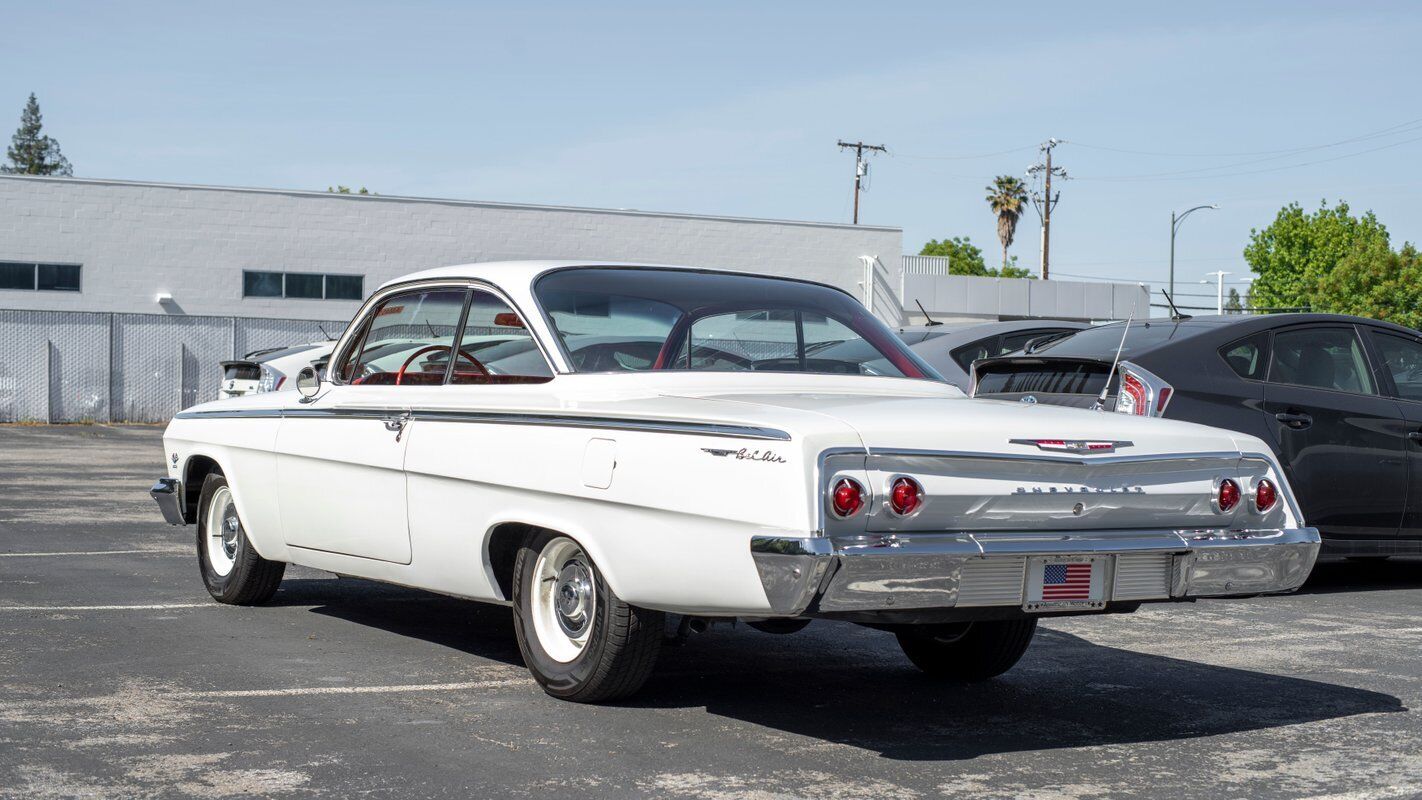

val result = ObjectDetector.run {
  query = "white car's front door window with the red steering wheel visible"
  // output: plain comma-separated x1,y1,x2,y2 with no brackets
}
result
338,288,468,387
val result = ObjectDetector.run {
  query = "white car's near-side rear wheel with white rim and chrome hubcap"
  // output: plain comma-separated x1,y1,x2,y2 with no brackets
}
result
512,533,665,703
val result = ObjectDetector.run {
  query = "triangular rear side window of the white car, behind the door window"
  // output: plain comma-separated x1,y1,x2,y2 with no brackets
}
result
445,291,553,384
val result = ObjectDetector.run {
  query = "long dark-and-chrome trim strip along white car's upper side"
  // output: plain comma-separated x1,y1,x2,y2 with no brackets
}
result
176,408,791,442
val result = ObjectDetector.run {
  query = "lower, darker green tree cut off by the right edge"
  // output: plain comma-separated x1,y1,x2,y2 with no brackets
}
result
1313,239,1422,328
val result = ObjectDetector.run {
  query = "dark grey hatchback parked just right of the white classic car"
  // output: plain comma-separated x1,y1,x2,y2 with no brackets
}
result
973,314,1422,556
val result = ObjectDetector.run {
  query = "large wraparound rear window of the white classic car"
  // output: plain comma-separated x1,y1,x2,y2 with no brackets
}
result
535,267,939,379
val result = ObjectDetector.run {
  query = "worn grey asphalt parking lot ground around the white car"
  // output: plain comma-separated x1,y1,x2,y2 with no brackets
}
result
0,426,1422,800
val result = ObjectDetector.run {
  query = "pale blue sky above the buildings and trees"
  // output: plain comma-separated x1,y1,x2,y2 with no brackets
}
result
0,1,1422,304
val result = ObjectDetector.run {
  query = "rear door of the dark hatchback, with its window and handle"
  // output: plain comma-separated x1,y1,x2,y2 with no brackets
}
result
1264,324,1408,544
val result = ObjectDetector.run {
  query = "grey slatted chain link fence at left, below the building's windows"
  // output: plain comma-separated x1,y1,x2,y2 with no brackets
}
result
0,310,346,422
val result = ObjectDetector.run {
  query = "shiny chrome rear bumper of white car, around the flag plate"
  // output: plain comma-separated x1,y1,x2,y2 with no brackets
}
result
751,527,1321,617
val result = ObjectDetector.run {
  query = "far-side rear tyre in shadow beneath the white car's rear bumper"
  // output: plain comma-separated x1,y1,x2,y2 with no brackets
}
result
897,618,1037,681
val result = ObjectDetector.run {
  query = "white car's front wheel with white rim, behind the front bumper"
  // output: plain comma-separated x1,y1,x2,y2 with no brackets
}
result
198,473,286,605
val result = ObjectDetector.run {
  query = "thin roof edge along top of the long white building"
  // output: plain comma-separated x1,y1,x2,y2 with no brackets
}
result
0,173,903,234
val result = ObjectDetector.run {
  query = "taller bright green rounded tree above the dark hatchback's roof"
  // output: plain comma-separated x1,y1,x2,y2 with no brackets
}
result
1244,200,1388,310
